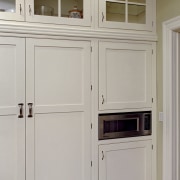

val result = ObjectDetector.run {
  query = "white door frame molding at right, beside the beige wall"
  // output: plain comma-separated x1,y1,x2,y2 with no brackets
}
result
163,16,180,180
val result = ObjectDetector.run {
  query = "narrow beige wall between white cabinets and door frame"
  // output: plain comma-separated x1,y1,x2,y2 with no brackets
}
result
156,0,180,180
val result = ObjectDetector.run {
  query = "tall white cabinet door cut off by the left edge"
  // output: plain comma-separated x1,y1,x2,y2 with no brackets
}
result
0,37,25,180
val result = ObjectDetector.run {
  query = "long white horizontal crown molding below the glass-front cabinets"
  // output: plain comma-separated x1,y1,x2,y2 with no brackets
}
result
0,21,157,42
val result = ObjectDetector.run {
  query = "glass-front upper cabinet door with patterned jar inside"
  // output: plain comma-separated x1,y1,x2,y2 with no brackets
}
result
26,0,91,26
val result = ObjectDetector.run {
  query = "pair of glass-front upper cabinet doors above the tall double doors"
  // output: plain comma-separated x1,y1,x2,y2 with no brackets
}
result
0,0,91,26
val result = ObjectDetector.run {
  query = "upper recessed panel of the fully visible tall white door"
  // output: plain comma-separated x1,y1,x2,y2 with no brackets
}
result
35,46,84,106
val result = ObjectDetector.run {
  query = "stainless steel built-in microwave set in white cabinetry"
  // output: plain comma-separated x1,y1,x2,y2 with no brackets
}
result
98,111,152,140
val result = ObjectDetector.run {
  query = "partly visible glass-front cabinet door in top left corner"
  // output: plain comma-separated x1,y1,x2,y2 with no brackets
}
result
0,0,25,21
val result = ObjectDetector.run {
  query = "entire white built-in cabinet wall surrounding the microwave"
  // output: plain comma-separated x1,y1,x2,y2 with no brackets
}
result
0,0,157,180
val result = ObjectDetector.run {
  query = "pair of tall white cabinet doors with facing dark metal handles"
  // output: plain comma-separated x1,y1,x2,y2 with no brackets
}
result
0,38,91,180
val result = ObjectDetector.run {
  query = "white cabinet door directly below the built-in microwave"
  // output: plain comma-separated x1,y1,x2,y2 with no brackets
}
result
99,140,152,180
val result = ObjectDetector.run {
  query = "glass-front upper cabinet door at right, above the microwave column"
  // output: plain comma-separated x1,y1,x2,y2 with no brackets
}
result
99,0,153,31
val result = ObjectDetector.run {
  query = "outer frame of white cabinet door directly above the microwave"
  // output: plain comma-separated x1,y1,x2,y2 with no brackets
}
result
99,41,152,111
